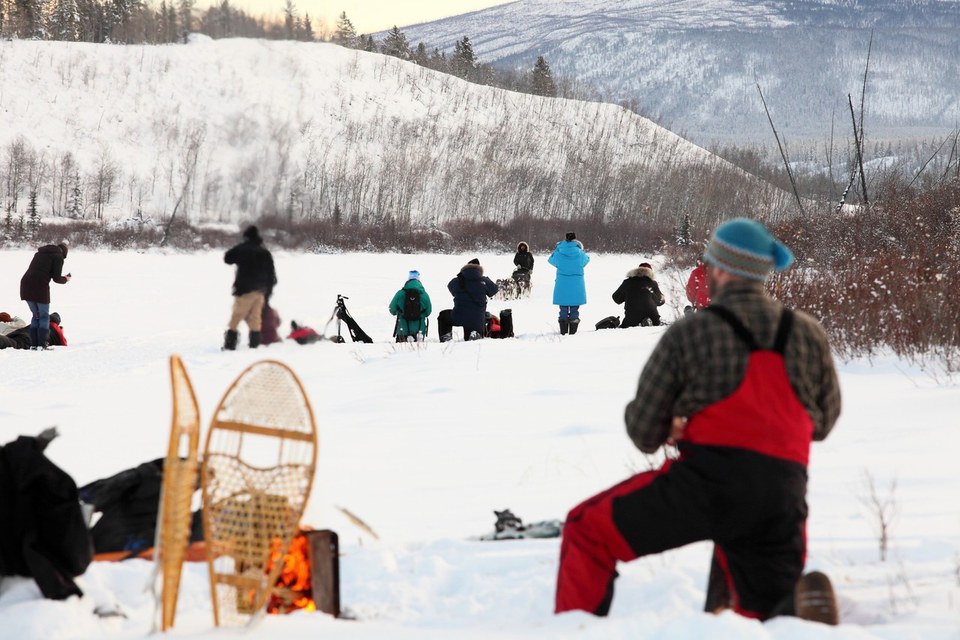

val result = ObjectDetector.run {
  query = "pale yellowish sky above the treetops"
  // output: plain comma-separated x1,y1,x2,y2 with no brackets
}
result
217,0,510,33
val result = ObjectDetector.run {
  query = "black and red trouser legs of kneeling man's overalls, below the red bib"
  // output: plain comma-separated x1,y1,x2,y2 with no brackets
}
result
556,447,807,619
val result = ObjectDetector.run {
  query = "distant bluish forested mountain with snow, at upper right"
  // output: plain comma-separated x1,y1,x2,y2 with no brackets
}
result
403,0,960,144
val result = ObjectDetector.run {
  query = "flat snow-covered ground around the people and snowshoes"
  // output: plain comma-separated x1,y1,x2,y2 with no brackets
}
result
0,249,960,640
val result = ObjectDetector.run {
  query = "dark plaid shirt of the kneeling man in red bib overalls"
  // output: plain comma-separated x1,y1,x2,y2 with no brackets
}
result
626,282,840,453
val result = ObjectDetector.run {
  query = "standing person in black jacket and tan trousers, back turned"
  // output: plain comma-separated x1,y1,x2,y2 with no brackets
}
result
223,225,277,351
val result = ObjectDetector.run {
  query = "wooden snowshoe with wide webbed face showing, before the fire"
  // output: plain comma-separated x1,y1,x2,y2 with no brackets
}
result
201,360,317,626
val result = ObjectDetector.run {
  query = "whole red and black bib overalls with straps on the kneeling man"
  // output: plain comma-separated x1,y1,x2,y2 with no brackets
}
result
556,309,813,619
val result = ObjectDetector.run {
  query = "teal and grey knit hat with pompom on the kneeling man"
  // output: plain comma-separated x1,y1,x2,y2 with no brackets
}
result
703,218,793,281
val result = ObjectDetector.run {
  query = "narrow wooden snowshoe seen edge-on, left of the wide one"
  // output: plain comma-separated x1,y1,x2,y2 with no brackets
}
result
154,355,200,631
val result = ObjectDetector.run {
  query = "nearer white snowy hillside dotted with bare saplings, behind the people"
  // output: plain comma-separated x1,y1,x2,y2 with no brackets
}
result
0,39,783,224
